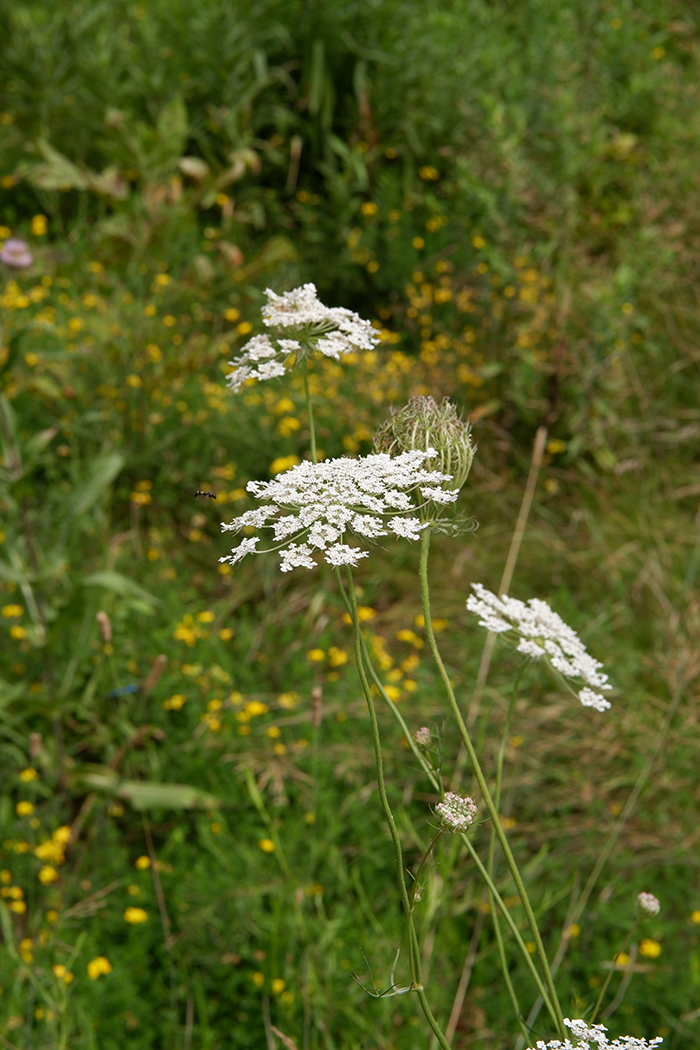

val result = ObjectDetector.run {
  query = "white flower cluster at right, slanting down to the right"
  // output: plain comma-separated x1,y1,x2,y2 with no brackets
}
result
467,584,612,711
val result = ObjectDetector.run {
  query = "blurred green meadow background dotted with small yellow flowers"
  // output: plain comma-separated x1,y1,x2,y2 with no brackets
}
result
0,0,700,1050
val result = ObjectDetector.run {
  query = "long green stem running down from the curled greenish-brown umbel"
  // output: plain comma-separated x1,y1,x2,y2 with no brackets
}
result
420,527,567,1040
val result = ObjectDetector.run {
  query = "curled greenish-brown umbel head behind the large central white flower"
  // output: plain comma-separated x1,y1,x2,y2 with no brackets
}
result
375,397,476,489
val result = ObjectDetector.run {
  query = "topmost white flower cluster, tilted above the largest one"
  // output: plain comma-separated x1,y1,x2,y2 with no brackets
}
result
227,285,379,393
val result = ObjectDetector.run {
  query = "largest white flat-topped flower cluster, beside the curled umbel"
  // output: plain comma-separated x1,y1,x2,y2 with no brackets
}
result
219,448,459,572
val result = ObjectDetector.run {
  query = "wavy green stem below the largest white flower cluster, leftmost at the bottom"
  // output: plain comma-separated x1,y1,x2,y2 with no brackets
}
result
345,565,450,1050
